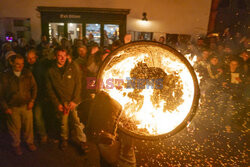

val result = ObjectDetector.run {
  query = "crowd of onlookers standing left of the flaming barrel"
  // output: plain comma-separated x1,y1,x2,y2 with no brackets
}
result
0,34,135,166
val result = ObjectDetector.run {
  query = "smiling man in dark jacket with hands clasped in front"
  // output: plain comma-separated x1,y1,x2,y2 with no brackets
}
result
46,47,87,152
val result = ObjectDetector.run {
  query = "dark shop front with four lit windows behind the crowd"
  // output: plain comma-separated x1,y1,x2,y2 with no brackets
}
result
37,6,130,46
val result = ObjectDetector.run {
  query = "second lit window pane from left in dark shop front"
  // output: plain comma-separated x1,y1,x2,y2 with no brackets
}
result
68,23,82,41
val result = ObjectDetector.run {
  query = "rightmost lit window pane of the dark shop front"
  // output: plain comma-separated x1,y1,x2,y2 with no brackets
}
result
104,24,119,46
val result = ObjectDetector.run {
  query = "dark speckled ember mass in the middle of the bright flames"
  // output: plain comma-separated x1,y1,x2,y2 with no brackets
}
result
128,62,183,112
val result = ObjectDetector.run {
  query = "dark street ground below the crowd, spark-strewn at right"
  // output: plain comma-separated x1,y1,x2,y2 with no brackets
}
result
0,94,250,167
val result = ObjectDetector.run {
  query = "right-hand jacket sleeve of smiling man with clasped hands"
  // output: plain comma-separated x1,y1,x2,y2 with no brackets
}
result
72,62,82,104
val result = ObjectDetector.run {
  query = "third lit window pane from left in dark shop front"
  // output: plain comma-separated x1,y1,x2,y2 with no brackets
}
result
86,24,101,44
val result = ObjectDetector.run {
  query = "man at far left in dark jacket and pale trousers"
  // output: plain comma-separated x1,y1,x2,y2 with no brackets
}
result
0,55,37,155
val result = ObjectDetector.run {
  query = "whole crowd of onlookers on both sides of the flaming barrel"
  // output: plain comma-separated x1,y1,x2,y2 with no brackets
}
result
0,29,247,166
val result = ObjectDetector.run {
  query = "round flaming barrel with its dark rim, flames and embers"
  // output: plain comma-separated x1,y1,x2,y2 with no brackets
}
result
98,41,199,139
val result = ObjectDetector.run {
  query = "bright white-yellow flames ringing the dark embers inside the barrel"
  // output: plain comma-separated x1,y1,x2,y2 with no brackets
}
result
98,45,198,136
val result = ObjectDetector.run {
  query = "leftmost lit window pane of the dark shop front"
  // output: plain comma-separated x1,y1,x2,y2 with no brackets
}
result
49,23,64,41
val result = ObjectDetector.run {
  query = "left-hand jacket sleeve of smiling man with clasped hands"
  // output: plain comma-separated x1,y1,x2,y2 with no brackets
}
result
45,70,61,106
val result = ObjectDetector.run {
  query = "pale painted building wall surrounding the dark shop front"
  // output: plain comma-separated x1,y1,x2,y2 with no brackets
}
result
0,0,212,40
